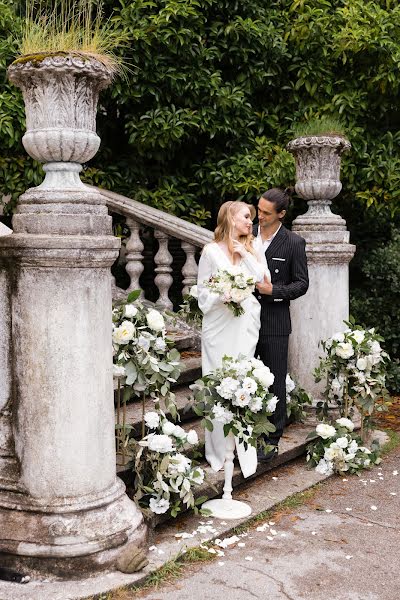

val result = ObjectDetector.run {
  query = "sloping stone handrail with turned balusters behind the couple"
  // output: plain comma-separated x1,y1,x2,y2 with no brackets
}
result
99,189,213,309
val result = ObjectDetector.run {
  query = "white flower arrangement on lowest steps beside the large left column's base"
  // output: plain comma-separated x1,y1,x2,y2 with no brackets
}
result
129,411,207,517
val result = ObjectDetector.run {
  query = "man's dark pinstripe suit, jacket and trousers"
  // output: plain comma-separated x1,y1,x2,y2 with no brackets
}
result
253,225,308,444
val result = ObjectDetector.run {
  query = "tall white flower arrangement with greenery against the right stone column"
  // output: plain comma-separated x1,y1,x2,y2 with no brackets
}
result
314,321,390,438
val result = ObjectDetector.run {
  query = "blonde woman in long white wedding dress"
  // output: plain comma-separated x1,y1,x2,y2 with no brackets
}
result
197,201,270,477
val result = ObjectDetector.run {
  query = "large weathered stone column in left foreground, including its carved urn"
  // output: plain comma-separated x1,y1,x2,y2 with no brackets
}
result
0,56,145,577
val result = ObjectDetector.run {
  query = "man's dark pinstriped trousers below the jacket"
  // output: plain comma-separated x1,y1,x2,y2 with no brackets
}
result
255,335,289,445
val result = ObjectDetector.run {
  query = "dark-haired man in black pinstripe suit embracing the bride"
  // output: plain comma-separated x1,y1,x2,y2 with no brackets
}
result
253,188,308,461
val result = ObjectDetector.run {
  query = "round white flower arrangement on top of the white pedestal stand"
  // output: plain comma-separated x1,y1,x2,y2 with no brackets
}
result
190,356,278,447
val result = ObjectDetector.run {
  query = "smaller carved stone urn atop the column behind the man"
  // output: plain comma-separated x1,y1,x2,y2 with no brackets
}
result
287,135,351,229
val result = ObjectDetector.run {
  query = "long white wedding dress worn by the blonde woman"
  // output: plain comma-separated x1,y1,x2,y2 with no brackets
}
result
197,242,270,477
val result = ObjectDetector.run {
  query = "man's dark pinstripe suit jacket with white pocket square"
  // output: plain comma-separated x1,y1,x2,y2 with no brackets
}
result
253,225,308,337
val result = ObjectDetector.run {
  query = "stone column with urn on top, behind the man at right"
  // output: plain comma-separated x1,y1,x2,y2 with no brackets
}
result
288,136,355,399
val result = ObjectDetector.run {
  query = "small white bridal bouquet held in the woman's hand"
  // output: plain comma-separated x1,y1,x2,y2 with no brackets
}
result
204,266,256,317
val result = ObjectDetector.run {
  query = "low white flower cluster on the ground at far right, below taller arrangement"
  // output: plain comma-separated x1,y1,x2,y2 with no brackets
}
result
307,417,381,475
